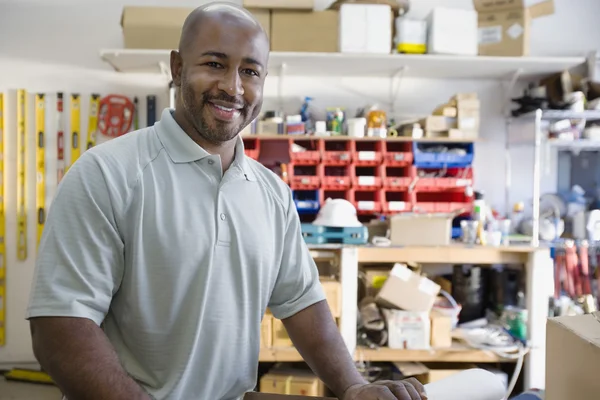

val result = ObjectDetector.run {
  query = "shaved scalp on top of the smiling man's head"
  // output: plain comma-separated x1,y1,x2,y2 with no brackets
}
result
179,1,268,57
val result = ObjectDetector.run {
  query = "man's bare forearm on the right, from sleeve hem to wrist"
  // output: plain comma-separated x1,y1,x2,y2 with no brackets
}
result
282,301,368,399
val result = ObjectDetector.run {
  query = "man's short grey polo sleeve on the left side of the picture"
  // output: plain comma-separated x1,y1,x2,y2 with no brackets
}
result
26,153,124,325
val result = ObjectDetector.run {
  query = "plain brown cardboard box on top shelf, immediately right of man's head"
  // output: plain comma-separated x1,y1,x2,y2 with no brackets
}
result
271,10,339,53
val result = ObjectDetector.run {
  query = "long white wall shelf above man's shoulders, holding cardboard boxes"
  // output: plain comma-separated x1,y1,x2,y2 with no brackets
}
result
100,49,586,80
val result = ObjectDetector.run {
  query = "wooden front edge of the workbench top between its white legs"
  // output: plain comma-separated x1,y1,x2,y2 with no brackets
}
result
358,245,547,264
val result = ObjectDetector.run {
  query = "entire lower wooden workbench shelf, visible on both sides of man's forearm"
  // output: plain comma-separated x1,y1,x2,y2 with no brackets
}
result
259,342,515,363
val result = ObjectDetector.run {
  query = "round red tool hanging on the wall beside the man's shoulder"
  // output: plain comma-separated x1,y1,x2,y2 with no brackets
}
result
98,94,135,137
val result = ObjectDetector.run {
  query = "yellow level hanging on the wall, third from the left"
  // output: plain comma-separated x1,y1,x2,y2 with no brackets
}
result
35,93,46,250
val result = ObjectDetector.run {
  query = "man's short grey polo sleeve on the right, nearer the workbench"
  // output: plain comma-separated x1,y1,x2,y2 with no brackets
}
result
269,188,325,319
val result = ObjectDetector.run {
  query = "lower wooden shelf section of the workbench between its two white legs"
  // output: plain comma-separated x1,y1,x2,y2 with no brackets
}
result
354,344,515,363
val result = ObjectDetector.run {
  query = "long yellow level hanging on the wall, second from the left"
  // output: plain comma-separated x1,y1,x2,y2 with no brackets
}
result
17,89,27,261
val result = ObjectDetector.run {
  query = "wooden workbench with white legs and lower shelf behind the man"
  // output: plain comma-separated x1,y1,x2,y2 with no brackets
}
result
260,244,554,389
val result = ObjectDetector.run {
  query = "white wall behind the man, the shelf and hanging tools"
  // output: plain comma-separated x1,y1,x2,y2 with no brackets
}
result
0,0,600,363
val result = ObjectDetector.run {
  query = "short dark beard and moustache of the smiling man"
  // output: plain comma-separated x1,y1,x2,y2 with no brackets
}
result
181,81,248,144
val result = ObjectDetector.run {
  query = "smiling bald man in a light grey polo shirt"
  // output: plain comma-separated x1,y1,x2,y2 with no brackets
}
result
28,3,425,400
